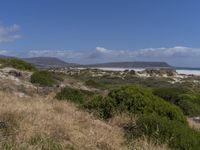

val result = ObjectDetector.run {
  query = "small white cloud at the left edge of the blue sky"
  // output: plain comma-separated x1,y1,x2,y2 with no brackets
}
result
0,24,21,43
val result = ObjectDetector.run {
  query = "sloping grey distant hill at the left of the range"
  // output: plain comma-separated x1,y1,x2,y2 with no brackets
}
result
23,57,76,68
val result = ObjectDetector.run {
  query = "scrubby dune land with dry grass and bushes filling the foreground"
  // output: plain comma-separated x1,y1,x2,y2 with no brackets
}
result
0,60,200,150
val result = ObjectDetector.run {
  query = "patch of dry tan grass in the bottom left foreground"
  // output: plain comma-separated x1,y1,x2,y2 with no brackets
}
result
0,92,125,149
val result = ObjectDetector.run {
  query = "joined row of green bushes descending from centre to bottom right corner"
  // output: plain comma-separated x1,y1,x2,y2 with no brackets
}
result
56,86,200,150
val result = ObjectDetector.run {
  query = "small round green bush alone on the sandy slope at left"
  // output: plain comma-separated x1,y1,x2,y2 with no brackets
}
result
31,71,56,86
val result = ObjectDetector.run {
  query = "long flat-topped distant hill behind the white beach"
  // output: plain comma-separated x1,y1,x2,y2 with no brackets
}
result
84,61,172,68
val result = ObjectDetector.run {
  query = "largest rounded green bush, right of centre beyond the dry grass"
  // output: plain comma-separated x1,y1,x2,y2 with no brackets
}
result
83,86,186,123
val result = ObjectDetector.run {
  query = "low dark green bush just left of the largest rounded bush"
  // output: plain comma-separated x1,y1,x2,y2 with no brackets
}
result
56,87,93,104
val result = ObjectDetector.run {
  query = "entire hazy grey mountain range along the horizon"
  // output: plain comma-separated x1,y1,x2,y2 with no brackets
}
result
0,55,172,68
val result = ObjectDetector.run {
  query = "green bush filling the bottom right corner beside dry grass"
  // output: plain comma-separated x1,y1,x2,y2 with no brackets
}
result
125,114,200,150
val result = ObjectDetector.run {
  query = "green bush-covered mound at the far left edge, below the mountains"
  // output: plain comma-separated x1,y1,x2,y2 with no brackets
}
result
0,58,36,71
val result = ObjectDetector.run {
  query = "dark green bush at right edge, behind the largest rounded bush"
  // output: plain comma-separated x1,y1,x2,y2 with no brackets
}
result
153,88,200,116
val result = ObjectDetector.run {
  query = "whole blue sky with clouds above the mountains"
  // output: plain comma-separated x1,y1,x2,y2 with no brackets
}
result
0,0,200,67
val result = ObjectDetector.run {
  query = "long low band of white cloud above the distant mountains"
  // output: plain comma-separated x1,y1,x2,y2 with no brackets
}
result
23,46,200,67
